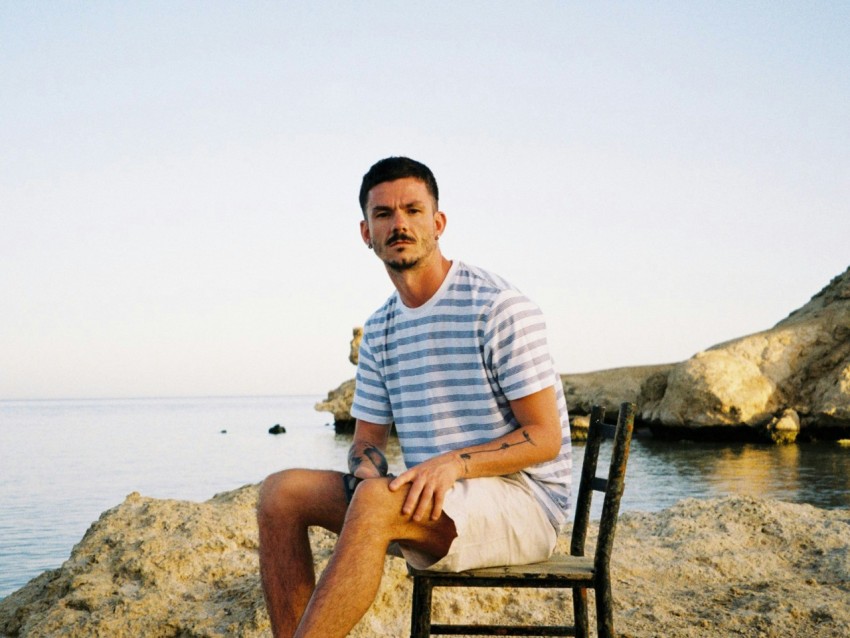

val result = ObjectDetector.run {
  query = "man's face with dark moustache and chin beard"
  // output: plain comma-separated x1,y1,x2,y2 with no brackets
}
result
360,177,445,271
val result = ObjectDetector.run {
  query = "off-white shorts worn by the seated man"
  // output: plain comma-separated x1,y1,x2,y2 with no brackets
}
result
400,474,558,572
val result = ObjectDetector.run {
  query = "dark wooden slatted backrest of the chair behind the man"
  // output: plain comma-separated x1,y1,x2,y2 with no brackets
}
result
570,403,635,570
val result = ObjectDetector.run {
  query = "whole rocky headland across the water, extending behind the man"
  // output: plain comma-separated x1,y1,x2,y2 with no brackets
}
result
316,268,850,443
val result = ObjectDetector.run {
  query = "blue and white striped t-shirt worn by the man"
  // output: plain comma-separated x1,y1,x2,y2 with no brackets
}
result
351,261,572,530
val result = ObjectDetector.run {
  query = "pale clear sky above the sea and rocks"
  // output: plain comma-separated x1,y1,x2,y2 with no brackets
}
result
0,0,850,400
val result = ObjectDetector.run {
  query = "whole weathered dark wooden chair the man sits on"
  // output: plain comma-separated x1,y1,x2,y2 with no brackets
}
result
408,403,635,638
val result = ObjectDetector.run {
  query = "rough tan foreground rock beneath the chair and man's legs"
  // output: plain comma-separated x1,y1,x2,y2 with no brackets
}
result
0,486,850,638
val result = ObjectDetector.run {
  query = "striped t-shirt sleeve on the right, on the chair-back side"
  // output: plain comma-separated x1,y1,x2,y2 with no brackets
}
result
485,290,557,401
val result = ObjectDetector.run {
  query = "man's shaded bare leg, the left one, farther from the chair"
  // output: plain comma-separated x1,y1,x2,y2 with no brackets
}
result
257,470,347,638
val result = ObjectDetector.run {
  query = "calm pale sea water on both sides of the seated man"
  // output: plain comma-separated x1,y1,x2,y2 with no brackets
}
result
0,397,850,598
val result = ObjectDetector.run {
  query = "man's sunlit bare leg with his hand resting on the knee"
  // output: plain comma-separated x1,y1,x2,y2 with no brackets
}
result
295,479,456,638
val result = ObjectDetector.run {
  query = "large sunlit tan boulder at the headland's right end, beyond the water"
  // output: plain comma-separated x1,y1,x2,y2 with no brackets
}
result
639,268,850,440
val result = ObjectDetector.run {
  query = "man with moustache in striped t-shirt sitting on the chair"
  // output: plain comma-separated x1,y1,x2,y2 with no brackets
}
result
257,157,571,638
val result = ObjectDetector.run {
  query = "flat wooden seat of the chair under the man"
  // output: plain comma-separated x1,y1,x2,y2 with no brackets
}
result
407,554,596,587
